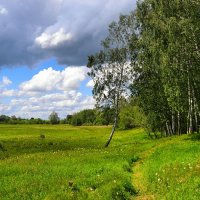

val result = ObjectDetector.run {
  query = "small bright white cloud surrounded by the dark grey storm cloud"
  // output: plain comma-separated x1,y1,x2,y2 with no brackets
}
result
35,28,72,49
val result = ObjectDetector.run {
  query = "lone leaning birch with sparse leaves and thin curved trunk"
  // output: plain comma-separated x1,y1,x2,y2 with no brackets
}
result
87,13,137,147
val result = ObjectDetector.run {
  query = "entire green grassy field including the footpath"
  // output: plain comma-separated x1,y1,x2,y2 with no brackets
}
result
0,125,200,200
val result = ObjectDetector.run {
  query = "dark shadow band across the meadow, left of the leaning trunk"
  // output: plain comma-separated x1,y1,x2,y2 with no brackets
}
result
0,138,104,160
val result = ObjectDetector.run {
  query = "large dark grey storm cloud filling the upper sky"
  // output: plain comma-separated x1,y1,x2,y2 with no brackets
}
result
0,0,135,67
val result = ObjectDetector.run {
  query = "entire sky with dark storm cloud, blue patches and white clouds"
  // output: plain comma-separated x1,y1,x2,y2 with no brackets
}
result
0,0,136,119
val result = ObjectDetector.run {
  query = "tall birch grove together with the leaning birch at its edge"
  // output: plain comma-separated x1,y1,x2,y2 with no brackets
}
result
87,0,200,146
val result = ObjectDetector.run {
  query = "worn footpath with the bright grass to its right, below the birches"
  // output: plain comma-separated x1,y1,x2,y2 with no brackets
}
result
132,135,200,200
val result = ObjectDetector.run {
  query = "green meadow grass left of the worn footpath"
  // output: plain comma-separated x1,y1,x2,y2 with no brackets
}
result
0,125,144,200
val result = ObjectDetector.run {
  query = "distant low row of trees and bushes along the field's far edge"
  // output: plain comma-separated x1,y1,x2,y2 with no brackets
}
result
0,100,145,130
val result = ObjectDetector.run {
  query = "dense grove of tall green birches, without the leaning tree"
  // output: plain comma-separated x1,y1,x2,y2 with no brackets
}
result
131,0,200,135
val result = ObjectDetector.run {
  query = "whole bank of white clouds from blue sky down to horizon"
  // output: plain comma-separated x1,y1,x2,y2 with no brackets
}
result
0,66,95,119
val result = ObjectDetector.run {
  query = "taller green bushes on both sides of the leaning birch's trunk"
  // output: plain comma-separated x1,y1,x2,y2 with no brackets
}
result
66,100,146,130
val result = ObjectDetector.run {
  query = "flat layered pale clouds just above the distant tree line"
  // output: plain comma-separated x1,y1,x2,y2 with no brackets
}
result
7,91,95,119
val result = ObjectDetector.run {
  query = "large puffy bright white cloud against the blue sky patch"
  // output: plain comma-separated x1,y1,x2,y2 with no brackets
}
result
20,67,88,92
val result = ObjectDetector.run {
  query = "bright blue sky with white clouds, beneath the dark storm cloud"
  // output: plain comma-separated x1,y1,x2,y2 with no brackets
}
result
0,58,95,119
